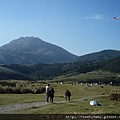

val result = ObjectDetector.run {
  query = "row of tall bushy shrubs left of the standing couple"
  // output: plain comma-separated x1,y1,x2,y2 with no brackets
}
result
0,80,45,94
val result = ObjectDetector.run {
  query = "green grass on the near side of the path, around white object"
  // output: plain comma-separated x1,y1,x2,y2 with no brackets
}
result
2,97,120,114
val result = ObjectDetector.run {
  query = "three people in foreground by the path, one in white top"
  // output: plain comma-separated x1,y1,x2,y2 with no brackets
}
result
46,84,71,103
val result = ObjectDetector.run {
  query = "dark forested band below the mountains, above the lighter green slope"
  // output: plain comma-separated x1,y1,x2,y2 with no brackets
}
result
0,57,120,80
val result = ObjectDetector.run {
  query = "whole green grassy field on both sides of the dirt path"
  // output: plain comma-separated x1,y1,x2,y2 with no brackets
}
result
0,84,120,114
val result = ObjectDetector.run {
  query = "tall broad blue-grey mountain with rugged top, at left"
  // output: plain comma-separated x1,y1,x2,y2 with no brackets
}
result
0,37,78,64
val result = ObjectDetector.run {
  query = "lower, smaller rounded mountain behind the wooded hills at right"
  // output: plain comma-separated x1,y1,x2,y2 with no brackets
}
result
77,50,120,61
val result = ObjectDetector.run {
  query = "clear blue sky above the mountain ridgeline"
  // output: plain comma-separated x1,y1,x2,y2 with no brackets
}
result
0,0,120,56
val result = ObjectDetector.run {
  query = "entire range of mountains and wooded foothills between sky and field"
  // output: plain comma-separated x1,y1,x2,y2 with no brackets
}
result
0,37,120,85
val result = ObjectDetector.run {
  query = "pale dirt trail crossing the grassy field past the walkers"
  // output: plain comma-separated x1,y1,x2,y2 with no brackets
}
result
0,95,107,114
